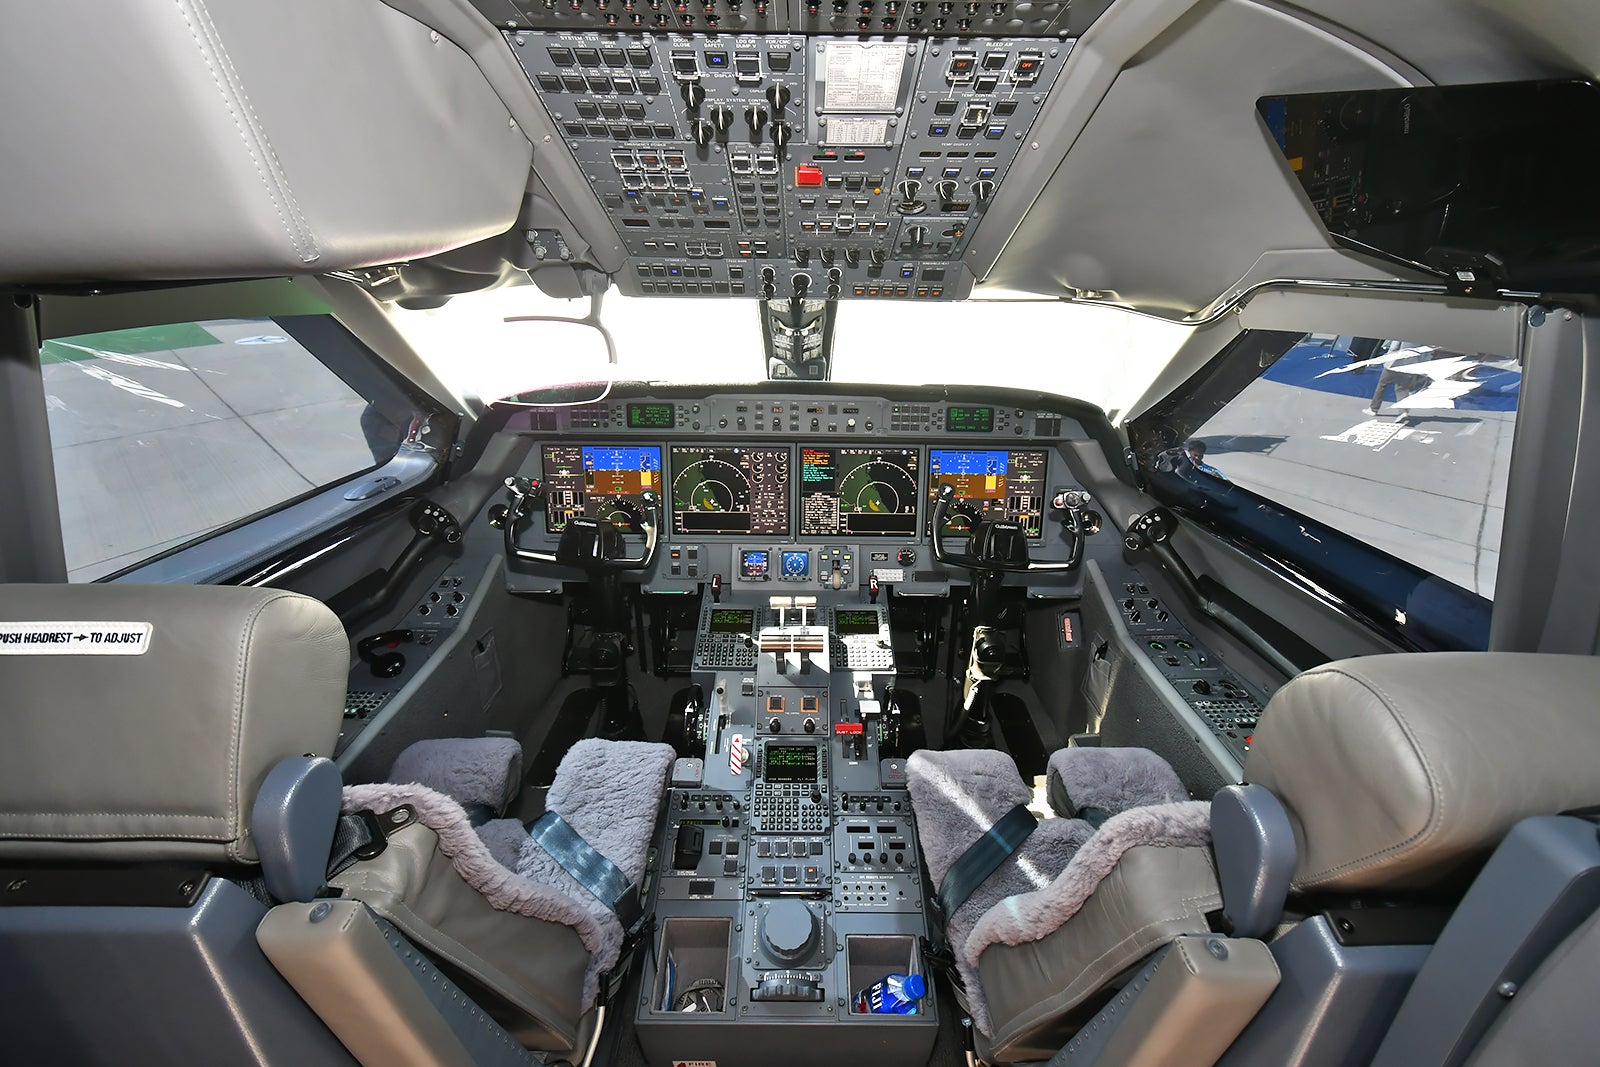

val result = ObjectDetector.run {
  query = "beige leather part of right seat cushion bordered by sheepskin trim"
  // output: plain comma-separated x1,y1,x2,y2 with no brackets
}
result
974,845,1222,1062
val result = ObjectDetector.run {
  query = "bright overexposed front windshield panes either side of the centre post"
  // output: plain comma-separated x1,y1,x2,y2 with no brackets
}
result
394,286,1189,421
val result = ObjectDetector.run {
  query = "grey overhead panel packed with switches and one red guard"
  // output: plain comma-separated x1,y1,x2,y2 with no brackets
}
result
506,30,1070,299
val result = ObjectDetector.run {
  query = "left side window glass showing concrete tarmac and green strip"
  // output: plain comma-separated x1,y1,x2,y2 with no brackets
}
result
40,318,396,582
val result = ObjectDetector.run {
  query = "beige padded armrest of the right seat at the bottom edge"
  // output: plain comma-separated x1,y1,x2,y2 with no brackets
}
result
1094,934,1278,1067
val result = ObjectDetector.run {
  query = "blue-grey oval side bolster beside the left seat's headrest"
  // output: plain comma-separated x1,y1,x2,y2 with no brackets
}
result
250,755,344,901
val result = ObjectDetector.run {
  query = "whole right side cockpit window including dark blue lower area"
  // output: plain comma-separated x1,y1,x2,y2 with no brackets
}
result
1136,333,1522,648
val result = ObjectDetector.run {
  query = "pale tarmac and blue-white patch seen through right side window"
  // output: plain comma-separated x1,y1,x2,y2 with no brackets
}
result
1184,334,1522,598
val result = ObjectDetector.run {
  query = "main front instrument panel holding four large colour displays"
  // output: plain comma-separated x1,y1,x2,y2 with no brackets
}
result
506,387,1088,593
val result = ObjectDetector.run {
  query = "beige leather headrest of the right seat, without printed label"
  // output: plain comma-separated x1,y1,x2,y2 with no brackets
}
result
1245,653,1600,893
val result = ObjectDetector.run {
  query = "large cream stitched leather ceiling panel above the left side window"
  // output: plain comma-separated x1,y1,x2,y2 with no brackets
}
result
0,0,531,285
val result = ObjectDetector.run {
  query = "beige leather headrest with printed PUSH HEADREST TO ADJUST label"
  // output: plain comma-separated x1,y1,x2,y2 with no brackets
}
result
0,585,349,862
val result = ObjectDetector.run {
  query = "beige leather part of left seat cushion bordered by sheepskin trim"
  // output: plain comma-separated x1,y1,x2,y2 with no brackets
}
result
330,822,589,1051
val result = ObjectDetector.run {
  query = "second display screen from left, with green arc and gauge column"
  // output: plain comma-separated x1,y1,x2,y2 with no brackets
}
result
672,445,789,536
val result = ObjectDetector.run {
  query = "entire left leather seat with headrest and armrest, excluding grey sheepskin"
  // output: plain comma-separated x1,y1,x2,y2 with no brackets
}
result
0,585,670,1067
